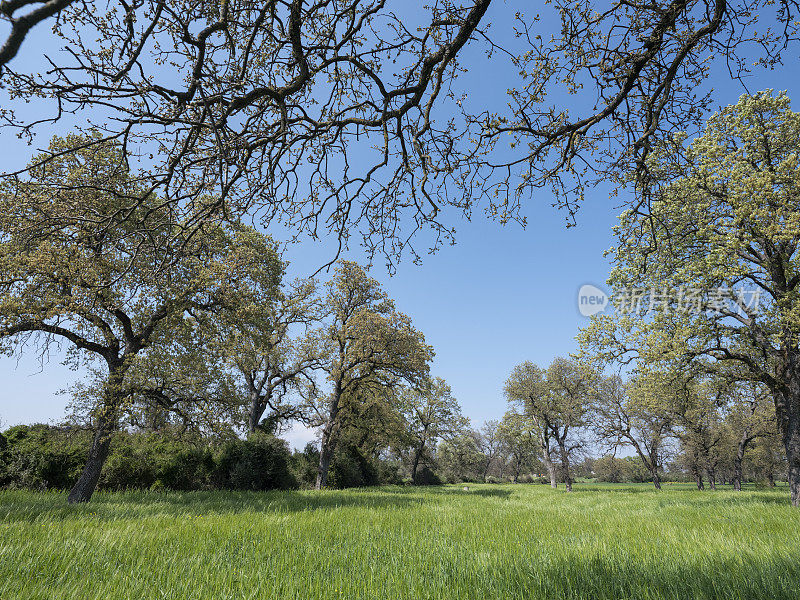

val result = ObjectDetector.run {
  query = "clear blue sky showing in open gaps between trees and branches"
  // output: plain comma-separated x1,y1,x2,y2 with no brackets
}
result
0,1,800,444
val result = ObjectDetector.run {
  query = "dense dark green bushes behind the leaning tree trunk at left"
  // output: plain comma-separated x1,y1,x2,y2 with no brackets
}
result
0,425,297,490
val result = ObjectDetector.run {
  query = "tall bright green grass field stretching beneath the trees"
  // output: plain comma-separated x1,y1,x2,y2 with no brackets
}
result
0,484,800,600
